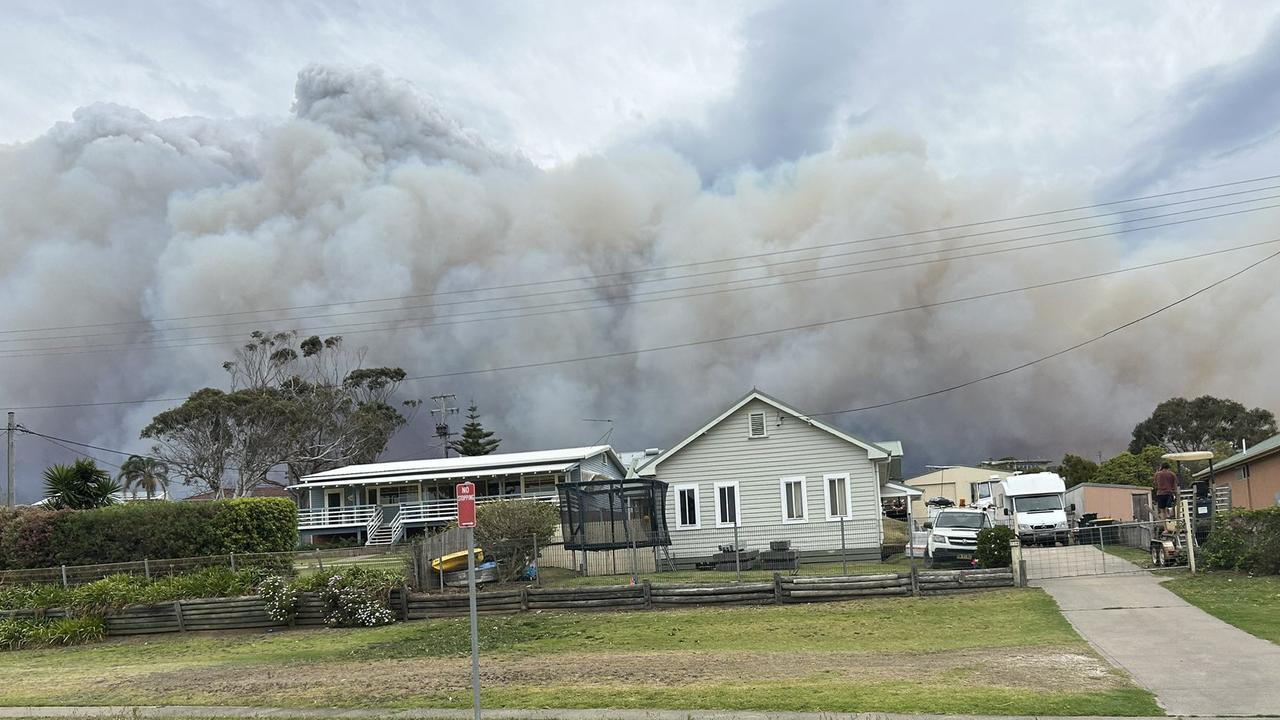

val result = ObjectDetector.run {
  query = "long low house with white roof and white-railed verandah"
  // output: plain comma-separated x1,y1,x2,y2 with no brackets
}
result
289,445,626,544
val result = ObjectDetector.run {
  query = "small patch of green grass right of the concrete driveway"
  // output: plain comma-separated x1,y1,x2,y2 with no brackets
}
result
1165,573,1280,643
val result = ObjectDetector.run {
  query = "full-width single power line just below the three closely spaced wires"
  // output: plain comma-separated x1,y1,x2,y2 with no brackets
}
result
9,238,1280,410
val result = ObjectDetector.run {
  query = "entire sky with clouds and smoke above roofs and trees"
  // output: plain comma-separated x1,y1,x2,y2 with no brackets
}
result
0,1,1280,500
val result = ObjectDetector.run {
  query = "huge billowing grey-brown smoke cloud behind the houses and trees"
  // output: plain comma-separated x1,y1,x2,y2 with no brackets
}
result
0,67,1280,500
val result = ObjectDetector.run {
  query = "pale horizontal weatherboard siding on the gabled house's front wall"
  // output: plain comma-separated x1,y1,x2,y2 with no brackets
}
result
655,400,882,564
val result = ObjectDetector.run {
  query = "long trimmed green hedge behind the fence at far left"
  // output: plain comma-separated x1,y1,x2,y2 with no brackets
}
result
0,497,298,570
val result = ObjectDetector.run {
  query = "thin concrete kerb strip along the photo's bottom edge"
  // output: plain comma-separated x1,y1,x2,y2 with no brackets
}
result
0,706,1215,720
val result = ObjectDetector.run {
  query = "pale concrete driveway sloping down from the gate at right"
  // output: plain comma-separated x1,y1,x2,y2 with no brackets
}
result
1030,573,1280,716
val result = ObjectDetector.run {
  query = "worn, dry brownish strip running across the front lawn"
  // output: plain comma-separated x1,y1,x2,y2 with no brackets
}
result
115,647,1128,703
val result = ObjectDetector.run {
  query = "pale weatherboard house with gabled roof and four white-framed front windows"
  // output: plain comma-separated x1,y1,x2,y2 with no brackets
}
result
636,391,918,566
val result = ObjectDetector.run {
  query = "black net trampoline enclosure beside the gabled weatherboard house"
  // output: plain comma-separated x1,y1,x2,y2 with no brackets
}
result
559,478,671,550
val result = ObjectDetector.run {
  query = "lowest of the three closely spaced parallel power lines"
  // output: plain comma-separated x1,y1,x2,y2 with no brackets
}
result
0,196,1280,359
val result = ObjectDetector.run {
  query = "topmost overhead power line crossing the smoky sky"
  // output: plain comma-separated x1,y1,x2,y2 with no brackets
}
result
0,174,1280,340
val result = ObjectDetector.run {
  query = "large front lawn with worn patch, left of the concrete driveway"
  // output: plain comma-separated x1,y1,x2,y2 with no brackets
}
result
0,589,1161,715
